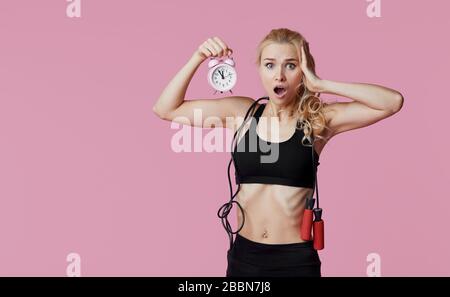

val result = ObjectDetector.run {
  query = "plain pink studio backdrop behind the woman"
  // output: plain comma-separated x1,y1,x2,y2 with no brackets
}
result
0,0,450,276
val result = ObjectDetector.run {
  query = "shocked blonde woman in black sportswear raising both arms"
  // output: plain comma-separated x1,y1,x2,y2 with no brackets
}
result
153,28,403,276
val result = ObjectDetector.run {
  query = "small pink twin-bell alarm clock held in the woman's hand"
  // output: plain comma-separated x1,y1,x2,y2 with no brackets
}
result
208,57,237,94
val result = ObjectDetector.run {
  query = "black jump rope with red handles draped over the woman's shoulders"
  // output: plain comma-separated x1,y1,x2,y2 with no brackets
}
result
217,97,324,250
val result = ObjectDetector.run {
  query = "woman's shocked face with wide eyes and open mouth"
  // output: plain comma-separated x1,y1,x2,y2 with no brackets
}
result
259,43,303,105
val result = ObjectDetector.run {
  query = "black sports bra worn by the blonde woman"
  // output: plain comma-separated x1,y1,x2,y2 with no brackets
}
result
232,104,320,189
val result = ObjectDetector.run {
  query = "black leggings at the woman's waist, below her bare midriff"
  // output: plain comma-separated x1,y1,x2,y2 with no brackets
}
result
226,233,321,277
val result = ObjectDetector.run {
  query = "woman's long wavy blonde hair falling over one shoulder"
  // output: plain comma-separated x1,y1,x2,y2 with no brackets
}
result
256,28,329,145
